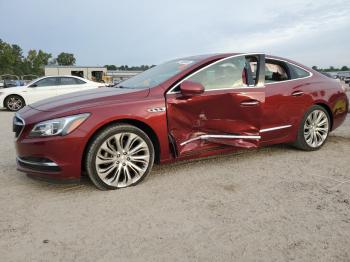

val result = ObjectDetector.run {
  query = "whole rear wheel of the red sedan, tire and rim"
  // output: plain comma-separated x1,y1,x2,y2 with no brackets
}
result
295,105,330,151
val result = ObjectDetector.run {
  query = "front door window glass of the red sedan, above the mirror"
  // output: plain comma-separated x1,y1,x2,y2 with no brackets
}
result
188,56,247,90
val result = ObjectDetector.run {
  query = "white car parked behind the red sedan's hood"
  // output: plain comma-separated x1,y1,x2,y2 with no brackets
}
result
0,76,105,111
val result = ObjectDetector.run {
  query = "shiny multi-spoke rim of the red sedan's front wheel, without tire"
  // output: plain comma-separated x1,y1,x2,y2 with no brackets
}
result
95,132,150,188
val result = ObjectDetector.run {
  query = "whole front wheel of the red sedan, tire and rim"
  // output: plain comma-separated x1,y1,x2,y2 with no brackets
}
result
85,124,154,190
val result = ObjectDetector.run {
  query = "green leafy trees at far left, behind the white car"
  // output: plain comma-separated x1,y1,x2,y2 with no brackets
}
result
0,39,75,76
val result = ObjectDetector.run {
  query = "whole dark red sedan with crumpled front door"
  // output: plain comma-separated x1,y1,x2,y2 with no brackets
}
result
13,54,349,189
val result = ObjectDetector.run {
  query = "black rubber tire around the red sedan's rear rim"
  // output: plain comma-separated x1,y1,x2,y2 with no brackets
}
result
293,105,331,151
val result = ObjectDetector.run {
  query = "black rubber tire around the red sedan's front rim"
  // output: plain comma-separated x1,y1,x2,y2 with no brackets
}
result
84,124,154,190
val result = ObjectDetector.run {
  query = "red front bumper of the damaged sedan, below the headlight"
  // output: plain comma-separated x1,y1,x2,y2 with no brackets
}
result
15,129,86,182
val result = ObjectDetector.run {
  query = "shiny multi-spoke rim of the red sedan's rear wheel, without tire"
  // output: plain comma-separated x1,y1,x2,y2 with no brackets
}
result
304,110,329,148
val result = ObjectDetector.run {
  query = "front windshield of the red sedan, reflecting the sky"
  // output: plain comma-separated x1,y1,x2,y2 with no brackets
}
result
115,56,203,89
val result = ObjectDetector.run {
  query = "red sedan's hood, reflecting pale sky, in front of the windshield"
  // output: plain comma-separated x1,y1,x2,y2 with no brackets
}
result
29,87,149,112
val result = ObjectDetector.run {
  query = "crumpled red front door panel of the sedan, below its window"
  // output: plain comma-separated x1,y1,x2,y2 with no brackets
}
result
166,53,265,156
